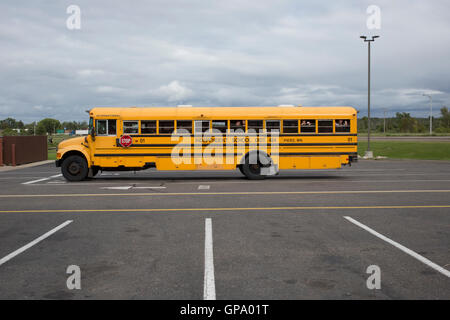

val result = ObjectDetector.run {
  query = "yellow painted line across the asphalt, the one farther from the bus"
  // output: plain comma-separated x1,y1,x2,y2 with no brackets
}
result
0,204,450,213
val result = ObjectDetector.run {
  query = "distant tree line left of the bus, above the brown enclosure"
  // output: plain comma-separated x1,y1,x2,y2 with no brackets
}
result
0,118,88,136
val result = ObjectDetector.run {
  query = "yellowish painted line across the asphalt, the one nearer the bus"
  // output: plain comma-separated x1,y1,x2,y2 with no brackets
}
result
0,190,450,198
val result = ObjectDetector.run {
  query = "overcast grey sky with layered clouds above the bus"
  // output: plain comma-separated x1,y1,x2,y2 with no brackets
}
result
0,0,450,122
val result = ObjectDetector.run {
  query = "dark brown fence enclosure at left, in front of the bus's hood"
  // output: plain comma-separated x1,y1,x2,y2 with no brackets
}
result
0,136,48,166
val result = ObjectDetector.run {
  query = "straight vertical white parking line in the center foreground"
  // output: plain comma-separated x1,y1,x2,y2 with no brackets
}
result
203,218,216,300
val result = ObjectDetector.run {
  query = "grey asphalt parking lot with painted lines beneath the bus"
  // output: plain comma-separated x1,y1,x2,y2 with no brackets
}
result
0,160,450,299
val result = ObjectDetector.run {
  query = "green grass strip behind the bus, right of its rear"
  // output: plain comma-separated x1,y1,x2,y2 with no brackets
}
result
358,141,450,160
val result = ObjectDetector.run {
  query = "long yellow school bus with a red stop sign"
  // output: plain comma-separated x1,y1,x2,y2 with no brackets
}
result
56,105,357,181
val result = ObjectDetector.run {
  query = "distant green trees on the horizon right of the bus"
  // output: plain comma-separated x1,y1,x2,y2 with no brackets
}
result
358,107,450,133
